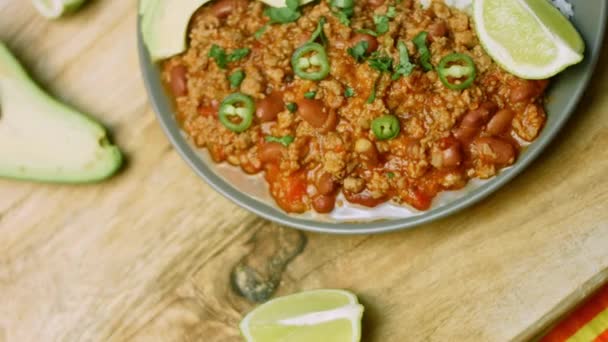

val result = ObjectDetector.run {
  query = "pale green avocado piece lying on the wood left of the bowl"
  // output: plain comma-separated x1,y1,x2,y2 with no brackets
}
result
0,42,122,183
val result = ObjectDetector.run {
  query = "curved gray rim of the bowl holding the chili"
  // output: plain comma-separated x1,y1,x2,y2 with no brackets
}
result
137,0,608,235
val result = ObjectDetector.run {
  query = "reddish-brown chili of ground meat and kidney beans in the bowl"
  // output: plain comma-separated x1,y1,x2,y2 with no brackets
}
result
162,0,547,212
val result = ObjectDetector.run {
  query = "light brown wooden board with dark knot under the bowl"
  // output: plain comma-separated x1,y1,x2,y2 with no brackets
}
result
0,0,608,342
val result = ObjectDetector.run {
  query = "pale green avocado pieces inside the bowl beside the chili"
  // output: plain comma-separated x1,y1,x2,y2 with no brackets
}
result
139,0,313,62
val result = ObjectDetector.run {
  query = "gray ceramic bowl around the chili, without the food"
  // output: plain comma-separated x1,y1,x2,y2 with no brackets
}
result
138,0,608,234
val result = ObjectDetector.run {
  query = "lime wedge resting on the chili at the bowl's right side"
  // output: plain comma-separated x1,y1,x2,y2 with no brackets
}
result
473,0,585,79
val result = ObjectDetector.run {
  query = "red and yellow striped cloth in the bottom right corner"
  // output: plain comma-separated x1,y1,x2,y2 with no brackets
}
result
540,285,608,342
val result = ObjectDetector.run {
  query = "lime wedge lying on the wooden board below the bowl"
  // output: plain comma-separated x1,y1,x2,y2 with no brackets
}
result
240,290,363,342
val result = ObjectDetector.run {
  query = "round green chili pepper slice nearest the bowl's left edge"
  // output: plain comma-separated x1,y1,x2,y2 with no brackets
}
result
219,93,255,133
